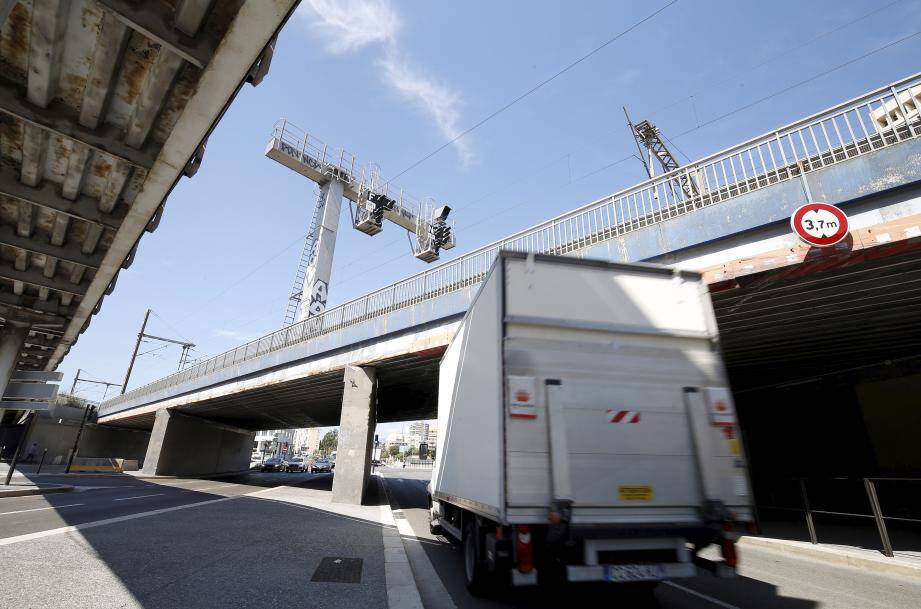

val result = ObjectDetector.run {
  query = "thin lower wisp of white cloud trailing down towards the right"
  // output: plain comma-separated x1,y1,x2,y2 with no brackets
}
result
378,48,473,167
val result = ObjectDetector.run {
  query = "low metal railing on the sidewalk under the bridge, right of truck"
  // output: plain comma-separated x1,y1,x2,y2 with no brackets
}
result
758,478,921,558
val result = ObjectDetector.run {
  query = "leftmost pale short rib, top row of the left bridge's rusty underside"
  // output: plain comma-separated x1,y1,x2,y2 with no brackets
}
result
27,0,70,108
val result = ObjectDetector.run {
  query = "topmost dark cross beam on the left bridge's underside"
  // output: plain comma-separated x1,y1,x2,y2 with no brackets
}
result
98,0,217,68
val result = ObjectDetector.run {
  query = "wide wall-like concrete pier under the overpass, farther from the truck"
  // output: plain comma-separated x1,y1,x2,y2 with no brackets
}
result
141,408,256,476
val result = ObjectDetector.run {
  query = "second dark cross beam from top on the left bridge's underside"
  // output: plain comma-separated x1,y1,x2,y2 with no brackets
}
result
0,80,158,169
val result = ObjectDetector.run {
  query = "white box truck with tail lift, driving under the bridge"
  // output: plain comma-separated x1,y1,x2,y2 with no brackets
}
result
429,252,754,593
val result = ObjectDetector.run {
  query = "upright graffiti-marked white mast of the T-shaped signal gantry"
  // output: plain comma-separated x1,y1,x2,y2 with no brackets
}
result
298,180,343,321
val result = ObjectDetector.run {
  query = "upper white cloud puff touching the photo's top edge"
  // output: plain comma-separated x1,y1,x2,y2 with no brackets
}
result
297,0,400,54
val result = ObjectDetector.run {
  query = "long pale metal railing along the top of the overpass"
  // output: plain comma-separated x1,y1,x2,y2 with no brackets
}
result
100,73,921,416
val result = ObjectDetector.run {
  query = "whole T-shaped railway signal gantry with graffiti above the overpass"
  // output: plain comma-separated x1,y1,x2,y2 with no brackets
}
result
265,119,455,326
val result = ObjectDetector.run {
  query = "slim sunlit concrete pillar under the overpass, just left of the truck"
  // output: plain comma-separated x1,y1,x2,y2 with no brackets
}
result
333,366,377,504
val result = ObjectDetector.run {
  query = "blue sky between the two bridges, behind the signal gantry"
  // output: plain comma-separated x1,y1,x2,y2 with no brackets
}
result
59,0,921,418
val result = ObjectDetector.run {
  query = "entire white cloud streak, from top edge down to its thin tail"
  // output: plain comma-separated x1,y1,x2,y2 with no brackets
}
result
298,0,474,167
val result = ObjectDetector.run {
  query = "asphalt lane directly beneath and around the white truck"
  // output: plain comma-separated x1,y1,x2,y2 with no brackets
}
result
381,469,921,609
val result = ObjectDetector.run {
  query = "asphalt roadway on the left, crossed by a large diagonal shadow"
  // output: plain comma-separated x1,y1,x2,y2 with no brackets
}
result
0,474,387,609
